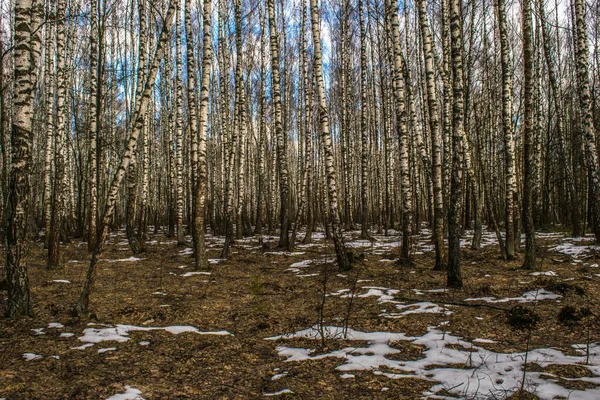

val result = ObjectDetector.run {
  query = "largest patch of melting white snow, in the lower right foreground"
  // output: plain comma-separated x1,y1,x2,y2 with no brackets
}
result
265,326,600,400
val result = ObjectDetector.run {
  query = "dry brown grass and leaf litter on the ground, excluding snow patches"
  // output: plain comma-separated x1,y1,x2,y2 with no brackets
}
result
0,228,600,399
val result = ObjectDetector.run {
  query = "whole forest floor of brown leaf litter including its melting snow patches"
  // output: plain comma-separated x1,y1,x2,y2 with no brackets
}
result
0,230,600,400
